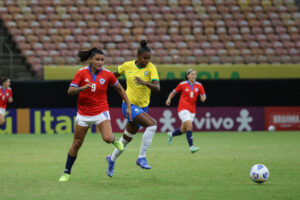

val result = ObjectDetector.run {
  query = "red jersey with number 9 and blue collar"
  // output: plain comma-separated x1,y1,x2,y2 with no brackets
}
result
70,66,119,116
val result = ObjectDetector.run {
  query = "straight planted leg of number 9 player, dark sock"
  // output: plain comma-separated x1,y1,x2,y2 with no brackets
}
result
59,124,89,182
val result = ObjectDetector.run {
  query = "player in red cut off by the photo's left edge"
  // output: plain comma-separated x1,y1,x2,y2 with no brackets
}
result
0,78,13,127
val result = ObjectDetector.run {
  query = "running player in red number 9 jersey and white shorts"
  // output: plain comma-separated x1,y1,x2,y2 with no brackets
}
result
59,48,131,182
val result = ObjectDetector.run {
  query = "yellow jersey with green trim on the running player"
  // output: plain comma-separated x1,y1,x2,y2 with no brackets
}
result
117,60,159,108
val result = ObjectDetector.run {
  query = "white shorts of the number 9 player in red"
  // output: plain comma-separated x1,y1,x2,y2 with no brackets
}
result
76,111,110,127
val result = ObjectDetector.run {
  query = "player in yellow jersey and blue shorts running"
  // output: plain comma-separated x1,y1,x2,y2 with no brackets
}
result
106,40,160,177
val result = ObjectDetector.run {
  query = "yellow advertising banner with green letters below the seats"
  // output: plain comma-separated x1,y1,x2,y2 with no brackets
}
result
44,64,300,80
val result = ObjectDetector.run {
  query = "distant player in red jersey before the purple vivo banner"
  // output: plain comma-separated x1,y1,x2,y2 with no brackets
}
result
166,69,206,153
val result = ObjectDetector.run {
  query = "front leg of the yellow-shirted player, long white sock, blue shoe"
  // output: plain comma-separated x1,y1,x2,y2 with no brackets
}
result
134,112,157,169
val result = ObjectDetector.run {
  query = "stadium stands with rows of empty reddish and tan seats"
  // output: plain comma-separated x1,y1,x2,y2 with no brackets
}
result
0,0,300,73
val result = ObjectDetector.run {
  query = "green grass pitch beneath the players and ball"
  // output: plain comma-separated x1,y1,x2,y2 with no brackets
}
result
0,132,300,200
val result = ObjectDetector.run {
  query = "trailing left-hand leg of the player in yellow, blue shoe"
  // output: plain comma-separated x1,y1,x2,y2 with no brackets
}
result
106,122,139,177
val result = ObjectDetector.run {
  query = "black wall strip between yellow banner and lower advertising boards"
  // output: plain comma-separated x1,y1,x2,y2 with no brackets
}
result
9,79,300,108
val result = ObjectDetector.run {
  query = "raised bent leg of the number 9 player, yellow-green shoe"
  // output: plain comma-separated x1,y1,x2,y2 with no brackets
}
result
97,120,124,151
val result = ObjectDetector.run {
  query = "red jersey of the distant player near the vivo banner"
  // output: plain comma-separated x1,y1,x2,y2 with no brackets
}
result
174,81,205,113
